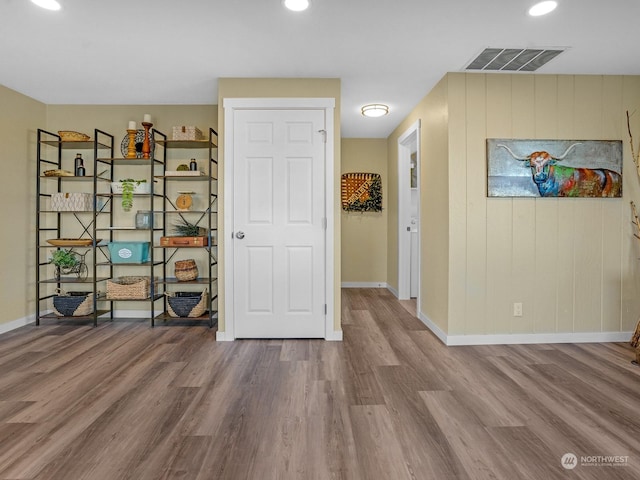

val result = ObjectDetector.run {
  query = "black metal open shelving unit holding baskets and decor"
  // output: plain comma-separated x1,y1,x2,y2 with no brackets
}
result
36,128,218,327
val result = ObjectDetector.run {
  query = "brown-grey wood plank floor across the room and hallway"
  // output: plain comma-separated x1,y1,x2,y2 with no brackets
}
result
0,289,640,480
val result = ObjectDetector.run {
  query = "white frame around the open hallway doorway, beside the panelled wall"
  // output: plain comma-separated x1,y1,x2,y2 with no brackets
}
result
398,120,422,304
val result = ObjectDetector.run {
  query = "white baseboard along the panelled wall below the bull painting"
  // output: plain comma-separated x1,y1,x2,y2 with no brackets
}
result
418,312,633,346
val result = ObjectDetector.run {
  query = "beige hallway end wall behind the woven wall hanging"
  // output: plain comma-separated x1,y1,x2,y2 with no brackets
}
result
341,138,389,284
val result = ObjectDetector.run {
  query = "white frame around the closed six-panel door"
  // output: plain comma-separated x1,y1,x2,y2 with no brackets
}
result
221,98,342,341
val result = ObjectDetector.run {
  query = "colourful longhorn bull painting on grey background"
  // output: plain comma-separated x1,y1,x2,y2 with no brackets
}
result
487,138,622,198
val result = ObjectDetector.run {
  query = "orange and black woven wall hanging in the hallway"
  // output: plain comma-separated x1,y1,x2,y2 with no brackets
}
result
341,173,382,212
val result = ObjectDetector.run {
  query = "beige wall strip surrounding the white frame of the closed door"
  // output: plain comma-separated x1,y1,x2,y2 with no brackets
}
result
218,78,341,331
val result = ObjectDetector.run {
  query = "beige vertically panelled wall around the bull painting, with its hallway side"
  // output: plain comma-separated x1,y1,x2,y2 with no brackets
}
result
389,73,640,335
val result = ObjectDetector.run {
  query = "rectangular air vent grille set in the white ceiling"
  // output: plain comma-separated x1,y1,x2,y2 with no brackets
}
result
465,48,564,72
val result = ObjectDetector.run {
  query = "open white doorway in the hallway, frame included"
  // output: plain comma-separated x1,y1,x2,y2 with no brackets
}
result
398,120,421,306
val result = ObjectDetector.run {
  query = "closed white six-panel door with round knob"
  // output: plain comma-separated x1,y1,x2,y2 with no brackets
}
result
232,110,326,338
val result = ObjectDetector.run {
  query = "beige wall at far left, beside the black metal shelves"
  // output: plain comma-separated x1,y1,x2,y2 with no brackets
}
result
0,85,46,330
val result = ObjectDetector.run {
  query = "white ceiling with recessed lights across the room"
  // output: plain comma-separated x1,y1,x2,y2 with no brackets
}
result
0,0,640,138
